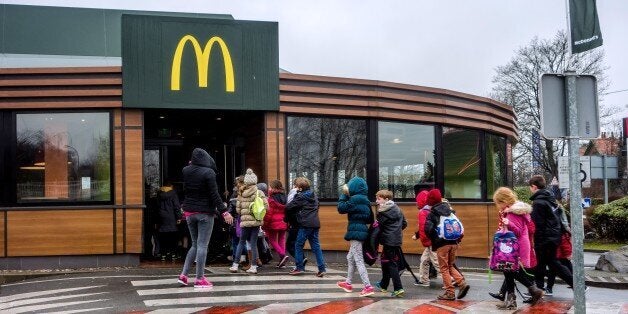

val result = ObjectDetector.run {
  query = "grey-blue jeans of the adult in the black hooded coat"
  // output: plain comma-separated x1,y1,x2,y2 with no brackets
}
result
181,213,214,280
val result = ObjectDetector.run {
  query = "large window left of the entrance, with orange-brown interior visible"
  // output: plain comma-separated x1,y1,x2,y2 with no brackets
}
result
16,112,111,203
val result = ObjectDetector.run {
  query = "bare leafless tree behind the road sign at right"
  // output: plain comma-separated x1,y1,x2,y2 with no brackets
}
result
491,30,609,182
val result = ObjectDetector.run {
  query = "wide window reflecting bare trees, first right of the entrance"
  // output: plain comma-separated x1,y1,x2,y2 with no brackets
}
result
286,117,366,199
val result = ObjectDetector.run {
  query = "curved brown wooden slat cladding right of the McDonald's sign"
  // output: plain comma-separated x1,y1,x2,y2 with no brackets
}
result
279,73,518,140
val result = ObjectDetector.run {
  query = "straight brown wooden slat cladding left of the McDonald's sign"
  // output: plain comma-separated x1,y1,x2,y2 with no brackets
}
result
0,67,122,109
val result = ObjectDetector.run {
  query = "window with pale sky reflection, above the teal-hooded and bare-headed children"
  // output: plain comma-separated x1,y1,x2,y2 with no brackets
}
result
378,122,435,199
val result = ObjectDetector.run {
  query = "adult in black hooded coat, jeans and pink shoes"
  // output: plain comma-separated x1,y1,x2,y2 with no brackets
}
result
178,148,233,288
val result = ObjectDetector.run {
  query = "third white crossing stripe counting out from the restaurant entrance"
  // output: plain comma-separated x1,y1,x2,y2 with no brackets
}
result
144,292,358,307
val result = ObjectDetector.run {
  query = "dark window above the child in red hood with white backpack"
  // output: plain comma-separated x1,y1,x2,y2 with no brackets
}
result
443,127,482,199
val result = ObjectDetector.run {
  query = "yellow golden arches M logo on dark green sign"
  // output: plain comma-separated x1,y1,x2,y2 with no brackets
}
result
170,35,235,93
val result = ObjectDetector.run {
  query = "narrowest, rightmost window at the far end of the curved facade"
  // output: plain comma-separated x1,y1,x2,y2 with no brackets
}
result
486,134,506,195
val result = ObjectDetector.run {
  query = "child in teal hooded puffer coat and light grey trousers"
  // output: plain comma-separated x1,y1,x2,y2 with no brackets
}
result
337,177,375,297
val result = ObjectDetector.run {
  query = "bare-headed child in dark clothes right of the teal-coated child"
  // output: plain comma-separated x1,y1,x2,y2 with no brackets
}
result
375,190,408,298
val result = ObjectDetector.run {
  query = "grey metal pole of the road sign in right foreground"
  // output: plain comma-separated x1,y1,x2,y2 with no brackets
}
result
565,71,586,314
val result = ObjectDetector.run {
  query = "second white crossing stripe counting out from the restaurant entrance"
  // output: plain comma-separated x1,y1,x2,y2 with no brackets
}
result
137,283,362,296
